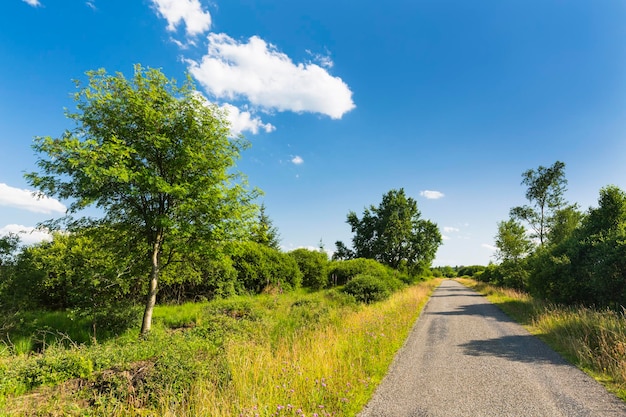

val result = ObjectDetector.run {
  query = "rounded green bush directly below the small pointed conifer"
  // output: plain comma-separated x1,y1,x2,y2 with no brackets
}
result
231,242,302,294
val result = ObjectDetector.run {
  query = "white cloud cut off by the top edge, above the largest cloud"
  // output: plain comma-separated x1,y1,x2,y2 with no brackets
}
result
150,0,211,35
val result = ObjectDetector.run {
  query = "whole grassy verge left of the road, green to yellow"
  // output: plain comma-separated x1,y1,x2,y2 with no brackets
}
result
0,280,440,417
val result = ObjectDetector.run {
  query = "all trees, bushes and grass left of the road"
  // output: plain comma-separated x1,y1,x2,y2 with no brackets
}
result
0,65,441,417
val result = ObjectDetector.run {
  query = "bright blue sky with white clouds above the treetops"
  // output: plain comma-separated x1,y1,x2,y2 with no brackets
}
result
0,0,626,265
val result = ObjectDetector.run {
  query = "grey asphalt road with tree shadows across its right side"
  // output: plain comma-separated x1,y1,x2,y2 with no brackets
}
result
359,280,626,417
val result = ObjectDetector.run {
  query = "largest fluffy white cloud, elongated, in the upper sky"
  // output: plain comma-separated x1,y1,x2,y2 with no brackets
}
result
188,33,355,119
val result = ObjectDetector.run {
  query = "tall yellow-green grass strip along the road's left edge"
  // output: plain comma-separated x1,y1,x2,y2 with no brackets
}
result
163,281,439,417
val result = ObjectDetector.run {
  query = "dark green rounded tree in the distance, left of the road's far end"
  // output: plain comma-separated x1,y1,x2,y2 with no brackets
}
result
347,188,441,272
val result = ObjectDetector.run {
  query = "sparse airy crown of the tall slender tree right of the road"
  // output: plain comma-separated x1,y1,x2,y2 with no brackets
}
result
511,161,567,245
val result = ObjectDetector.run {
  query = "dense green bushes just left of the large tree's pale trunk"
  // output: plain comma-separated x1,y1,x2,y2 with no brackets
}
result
4,227,140,337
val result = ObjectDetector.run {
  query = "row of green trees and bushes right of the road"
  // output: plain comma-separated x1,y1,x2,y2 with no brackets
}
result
473,161,626,309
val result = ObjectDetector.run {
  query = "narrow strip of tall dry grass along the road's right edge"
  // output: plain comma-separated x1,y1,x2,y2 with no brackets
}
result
459,279,626,401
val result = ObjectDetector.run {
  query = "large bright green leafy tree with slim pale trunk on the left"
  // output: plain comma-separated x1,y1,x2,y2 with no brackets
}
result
26,65,255,334
